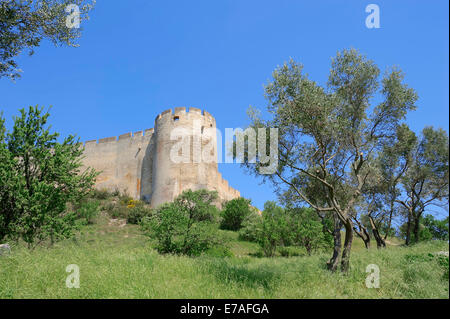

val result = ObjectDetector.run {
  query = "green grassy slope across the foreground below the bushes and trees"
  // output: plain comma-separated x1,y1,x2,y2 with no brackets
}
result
0,215,449,298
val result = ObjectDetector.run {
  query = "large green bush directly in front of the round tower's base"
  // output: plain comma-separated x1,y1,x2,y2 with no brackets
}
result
141,190,217,256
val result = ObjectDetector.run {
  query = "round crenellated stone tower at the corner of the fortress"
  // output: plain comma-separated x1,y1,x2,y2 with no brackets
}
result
151,107,221,207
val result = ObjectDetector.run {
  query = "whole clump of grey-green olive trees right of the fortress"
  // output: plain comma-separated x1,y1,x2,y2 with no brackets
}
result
234,49,449,273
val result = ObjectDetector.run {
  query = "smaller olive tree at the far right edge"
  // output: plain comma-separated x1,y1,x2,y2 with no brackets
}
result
396,127,449,245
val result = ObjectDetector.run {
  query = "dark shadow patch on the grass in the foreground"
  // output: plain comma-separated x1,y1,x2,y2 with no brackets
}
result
208,259,281,290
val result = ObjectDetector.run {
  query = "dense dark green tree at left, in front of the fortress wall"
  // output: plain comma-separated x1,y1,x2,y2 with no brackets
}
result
0,106,97,247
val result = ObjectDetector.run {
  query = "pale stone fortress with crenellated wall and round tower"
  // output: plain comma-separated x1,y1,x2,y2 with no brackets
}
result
83,107,240,207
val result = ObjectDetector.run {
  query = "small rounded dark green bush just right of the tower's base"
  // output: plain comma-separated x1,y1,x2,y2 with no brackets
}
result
220,197,251,230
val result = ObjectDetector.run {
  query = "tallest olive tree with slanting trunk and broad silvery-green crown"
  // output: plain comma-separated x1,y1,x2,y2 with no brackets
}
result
237,50,417,272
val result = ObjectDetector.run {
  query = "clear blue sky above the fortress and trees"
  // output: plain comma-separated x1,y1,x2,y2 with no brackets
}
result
0,0,449,212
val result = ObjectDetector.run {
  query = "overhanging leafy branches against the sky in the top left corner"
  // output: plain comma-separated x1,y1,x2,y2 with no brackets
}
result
0,0,95,80
